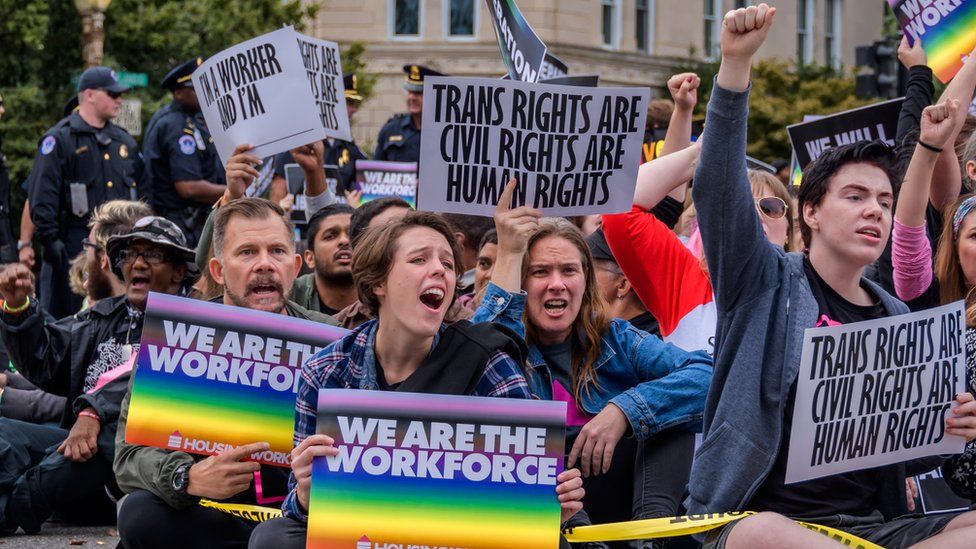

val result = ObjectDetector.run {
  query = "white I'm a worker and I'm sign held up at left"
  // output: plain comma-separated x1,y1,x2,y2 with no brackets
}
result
193,27,328,164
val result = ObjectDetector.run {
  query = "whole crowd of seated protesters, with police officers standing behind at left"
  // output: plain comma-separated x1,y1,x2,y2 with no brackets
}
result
0,4,976,549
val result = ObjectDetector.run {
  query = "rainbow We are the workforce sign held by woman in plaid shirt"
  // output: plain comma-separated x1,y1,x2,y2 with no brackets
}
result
307,389,566,549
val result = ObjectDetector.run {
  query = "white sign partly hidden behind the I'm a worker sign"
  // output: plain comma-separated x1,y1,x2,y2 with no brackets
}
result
298,34,352,141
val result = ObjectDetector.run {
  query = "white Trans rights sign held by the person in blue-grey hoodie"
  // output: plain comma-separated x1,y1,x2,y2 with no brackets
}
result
786,301,966,484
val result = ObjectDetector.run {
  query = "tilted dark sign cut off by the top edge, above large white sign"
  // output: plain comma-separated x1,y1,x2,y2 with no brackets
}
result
485,0,548,82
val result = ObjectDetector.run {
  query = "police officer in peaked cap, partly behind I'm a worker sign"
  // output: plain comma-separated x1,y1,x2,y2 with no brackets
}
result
143,57,226,247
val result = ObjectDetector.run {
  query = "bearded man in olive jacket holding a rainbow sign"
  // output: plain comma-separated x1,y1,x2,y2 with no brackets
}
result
114,195,336,549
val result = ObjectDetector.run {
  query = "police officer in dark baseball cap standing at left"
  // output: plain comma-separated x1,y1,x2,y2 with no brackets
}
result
29,67,148,318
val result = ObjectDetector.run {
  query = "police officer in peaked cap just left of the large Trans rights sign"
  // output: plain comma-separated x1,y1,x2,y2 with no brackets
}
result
373,65,445,162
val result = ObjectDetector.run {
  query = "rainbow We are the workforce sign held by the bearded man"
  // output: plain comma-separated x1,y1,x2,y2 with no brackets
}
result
125,293,347,467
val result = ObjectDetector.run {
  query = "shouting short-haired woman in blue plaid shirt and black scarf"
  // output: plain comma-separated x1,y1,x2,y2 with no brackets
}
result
249,212,582,549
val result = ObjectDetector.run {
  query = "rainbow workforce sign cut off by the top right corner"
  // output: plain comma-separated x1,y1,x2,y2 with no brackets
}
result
888,0,976,84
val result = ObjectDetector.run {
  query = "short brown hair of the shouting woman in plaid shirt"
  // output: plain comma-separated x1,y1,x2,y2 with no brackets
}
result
352,211,463,317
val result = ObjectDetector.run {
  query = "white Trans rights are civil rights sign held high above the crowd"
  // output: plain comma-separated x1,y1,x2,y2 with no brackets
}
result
417,77,650,215
